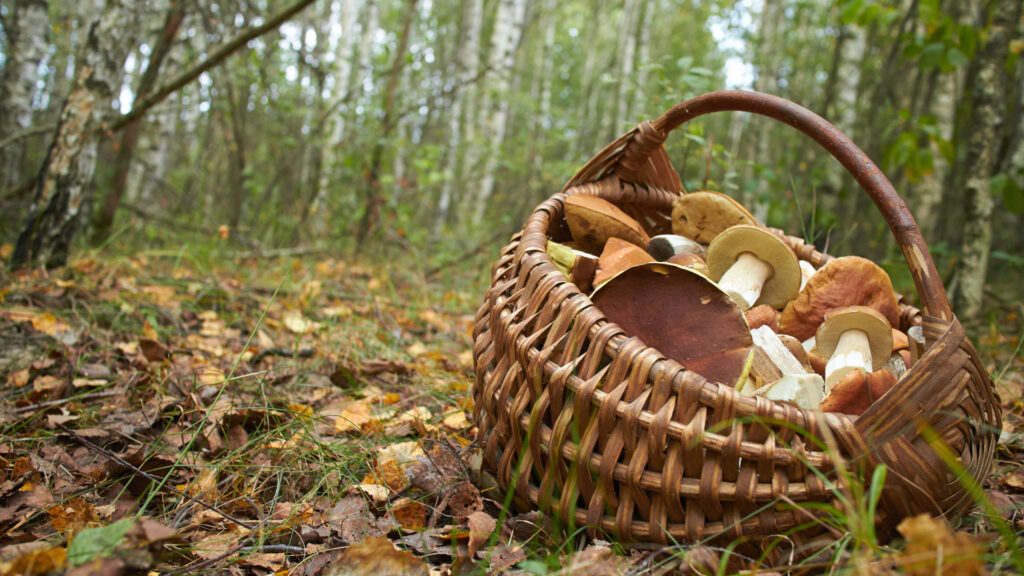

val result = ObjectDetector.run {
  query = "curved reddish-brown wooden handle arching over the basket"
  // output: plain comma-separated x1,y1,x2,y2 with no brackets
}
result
616,90,953,321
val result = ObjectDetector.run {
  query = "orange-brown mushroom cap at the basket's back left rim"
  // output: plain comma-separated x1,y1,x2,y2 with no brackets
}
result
565,194,649,253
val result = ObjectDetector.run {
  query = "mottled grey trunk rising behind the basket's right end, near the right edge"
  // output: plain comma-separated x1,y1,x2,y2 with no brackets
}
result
954,0,1021,319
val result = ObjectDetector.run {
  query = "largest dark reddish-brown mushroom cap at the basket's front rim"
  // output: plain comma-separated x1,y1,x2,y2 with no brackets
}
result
591,262,753,386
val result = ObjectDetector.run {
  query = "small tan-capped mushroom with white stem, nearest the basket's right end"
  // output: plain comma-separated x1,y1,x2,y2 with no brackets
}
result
814,306,893,394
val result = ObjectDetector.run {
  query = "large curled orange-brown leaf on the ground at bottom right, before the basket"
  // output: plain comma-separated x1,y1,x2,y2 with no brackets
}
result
896,515,985,576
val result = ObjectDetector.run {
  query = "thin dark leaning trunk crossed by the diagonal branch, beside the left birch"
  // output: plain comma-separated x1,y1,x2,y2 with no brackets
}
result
92,0,185,244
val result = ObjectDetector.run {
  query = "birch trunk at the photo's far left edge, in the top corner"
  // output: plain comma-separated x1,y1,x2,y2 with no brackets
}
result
0,0,50,192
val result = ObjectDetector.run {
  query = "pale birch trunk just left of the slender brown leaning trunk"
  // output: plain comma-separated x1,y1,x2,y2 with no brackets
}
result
310,0,356,238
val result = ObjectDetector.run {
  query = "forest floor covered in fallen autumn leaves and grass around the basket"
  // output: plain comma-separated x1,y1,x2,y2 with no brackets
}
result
0,236,1024,576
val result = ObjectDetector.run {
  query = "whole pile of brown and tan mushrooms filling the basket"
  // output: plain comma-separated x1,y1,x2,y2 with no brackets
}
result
548,192,923,415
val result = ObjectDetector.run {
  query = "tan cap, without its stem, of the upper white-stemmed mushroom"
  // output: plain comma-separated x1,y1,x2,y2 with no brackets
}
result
706,225,800,308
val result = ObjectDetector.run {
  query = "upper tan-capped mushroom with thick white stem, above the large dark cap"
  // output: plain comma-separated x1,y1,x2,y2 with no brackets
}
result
708,225,800,311
